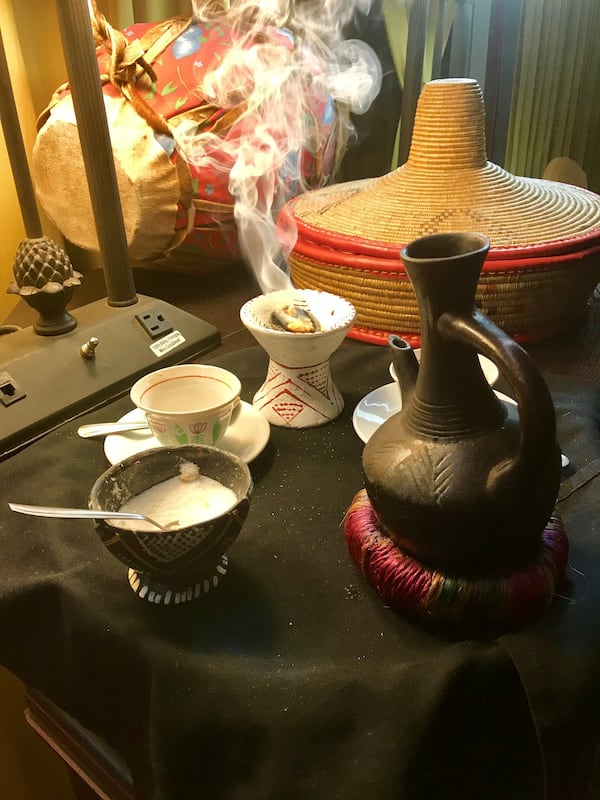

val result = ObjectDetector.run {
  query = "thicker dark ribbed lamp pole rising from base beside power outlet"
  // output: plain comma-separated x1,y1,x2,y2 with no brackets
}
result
57,0,137,306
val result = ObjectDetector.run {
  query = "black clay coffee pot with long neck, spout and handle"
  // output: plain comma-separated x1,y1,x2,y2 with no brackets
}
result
363,233,561,574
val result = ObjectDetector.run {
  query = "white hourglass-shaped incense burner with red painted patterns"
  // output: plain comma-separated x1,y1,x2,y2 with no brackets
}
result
240,289,355,428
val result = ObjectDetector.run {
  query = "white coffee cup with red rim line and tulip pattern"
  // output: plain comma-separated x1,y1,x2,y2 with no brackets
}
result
129,364,242,447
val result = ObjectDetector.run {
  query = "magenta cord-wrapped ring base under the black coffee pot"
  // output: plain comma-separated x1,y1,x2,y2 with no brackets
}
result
344,489,569,630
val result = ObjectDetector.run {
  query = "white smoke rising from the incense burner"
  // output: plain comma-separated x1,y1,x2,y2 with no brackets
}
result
176,0,381,292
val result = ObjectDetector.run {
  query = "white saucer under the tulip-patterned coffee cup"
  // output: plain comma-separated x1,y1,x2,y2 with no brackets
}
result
104,400,271,464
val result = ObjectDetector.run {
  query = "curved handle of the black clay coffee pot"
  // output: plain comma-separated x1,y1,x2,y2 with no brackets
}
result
438,309,560,488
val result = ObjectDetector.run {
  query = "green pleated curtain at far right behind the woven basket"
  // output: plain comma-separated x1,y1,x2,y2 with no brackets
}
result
505,0,600,191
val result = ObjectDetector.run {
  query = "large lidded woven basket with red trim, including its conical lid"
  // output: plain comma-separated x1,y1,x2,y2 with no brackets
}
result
280,79,600,346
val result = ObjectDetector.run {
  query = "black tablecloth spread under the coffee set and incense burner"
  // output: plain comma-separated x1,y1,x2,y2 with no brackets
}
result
0,341,600,800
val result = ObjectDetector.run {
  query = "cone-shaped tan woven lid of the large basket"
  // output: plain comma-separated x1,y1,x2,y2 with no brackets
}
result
285,78,600,259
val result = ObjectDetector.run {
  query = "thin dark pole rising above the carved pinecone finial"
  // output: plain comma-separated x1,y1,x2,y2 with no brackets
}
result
0,31,44,239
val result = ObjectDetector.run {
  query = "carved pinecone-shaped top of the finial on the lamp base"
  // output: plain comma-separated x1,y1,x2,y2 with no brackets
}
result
8,236,81,295
